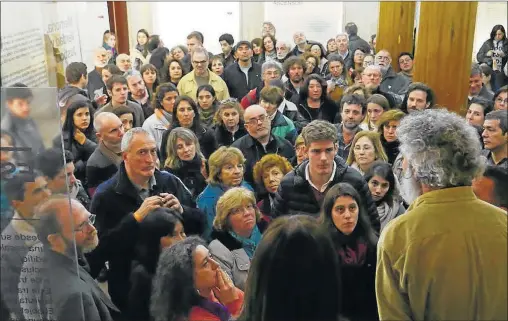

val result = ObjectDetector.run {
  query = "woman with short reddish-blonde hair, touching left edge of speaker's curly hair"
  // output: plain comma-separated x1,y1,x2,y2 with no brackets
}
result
376,109,406,165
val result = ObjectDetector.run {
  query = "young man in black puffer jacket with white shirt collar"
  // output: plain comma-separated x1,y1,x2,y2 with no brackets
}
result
272,120,380,233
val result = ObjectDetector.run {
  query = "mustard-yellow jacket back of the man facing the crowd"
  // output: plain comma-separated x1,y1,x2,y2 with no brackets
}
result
376,187,508,320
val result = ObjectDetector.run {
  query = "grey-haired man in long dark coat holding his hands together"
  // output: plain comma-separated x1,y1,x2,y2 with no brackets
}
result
87,127,205,311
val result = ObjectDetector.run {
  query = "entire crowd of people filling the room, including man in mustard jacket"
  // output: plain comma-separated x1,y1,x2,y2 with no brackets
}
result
0,22,508,321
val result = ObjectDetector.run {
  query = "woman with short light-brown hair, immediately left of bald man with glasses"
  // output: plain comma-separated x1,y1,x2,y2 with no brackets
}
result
213,99,247,146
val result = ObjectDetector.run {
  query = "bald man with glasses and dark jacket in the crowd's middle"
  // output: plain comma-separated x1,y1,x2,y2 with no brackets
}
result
231,105,295,186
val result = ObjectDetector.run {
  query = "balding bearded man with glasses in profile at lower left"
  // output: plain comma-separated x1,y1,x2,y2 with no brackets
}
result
29,195,120,321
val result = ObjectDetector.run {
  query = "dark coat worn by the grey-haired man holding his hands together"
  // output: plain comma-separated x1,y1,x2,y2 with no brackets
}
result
87,163,205,311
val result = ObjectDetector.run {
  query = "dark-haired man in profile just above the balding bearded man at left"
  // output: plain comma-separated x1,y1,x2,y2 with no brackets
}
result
35,148,90,209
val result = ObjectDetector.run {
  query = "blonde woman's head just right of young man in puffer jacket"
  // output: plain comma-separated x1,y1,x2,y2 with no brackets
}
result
346,131,388,175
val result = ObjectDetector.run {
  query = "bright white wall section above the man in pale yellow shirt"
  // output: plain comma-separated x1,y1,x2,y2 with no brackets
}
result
152,2,240,54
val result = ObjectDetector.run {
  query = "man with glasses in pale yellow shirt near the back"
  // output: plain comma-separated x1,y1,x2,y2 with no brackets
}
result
177,47,229,101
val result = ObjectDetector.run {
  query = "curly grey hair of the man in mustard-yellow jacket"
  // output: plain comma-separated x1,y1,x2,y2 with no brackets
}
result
397,109,485,188
